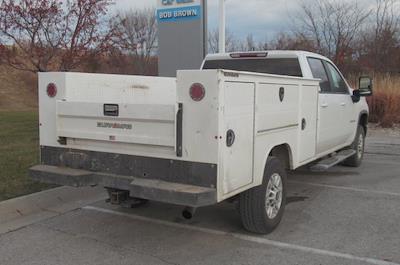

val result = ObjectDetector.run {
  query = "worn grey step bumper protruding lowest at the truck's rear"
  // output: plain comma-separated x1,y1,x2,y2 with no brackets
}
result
29,165,217,207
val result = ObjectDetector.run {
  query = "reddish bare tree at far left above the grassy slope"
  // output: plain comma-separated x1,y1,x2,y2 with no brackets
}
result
0,0,112,72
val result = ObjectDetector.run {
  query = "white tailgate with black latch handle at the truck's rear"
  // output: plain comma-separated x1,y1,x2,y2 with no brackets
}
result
56,100,177,148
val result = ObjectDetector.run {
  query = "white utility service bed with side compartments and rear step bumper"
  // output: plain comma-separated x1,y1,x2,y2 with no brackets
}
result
30,70,319,207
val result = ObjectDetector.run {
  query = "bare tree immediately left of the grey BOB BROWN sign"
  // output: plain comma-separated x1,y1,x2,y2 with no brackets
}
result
115,8,157,74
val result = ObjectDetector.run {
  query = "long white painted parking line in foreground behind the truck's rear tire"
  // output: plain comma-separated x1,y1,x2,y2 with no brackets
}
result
82,206,400,265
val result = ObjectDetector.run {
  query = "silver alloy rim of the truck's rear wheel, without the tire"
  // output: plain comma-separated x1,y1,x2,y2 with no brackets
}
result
265,173,283,219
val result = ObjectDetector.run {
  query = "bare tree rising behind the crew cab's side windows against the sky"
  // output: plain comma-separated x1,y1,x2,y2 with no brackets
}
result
294,0,370,69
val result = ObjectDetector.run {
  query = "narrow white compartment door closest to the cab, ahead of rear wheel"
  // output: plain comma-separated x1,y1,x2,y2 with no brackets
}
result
298,86,318,163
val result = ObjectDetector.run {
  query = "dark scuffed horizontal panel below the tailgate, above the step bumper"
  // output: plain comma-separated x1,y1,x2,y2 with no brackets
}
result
40,146,218,188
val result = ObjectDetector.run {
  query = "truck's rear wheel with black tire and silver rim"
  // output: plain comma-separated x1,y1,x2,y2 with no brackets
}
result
239,157,287,234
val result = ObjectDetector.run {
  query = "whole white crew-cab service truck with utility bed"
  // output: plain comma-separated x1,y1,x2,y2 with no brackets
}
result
30,51,372,233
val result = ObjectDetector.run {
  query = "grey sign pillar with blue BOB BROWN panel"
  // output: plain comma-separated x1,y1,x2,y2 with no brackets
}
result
157,0,207,77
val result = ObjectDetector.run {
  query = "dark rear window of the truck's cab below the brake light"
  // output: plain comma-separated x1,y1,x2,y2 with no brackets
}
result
203,58,303,77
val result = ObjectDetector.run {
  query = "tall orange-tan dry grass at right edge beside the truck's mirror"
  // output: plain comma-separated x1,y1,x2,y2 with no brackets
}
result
367,74,400,128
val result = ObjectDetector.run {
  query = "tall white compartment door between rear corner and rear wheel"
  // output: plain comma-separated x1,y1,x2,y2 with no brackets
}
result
222,82,255,194
